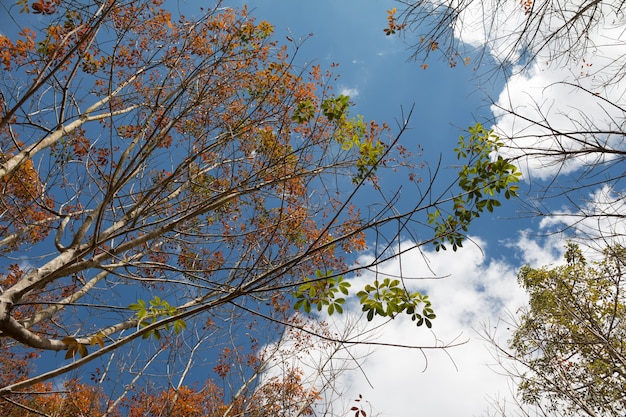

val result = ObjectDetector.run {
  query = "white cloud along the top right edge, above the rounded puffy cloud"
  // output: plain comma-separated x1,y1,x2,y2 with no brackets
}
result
444,0,626,68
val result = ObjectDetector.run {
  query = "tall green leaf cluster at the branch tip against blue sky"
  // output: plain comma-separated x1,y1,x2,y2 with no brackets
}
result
428,123,522,251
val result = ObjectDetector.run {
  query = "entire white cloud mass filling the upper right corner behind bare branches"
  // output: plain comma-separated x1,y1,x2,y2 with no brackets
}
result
435,0,626,179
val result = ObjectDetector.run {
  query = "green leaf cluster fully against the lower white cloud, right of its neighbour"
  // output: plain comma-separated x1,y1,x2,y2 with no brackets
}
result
357,278,436,329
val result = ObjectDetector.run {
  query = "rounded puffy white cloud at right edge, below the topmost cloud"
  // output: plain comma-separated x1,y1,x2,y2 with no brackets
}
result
492,62,626,179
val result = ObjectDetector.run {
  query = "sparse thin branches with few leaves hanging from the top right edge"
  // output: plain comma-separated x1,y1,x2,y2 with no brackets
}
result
386,0,624,73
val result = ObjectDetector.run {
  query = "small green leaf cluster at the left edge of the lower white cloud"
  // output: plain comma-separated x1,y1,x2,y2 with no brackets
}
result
293,269,350,316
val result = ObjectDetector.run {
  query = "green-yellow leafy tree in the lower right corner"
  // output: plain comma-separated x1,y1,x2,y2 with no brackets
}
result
491,243,626,416
